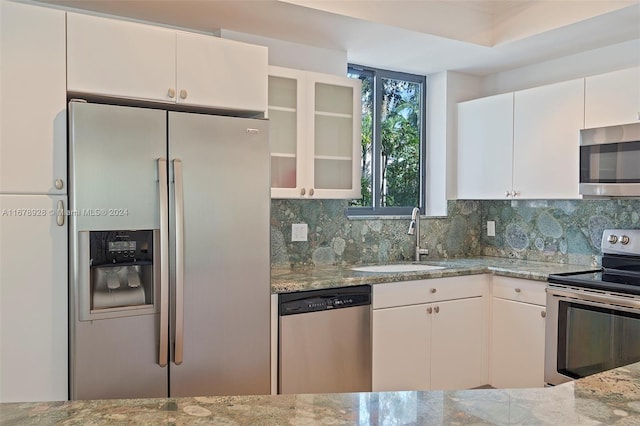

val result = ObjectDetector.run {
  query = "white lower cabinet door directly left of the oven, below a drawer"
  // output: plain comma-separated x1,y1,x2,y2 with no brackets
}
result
490,297,545,388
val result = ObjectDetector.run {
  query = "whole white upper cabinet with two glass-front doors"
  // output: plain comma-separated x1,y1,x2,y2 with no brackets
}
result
268,67,361,198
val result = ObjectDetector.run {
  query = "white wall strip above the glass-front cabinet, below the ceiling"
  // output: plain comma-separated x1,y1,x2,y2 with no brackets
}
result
220,29,347,76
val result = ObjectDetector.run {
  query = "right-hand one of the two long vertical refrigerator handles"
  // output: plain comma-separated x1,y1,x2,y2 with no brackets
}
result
173,159,184,365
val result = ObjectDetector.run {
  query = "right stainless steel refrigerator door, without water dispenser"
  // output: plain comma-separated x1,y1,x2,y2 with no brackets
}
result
169,112,271,397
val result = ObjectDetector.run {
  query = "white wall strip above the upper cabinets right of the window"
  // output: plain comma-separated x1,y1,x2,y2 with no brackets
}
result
482,39,640,96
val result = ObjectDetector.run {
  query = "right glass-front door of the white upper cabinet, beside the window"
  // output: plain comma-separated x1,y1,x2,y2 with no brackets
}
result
305,73,362,198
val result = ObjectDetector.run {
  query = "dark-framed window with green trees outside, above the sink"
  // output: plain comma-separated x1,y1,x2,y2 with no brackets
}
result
348,65,426,215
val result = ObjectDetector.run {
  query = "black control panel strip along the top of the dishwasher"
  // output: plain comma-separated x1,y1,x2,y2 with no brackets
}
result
279,285,371,315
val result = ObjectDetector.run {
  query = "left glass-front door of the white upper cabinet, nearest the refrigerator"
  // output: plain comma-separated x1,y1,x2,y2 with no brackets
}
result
268,67,306,198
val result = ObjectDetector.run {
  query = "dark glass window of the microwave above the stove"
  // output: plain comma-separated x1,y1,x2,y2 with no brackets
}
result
580,141,640,183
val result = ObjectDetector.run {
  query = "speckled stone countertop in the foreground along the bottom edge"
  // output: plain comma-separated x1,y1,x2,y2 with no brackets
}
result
0,363,640,426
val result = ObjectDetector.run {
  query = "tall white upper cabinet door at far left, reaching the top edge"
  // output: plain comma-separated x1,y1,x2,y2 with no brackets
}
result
0,1,67,195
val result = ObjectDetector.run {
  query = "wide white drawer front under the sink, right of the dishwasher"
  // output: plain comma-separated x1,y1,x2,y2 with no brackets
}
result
373,274,488,309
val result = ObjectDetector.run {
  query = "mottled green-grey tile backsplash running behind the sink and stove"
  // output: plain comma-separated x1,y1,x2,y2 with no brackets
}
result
271,200,640,266
